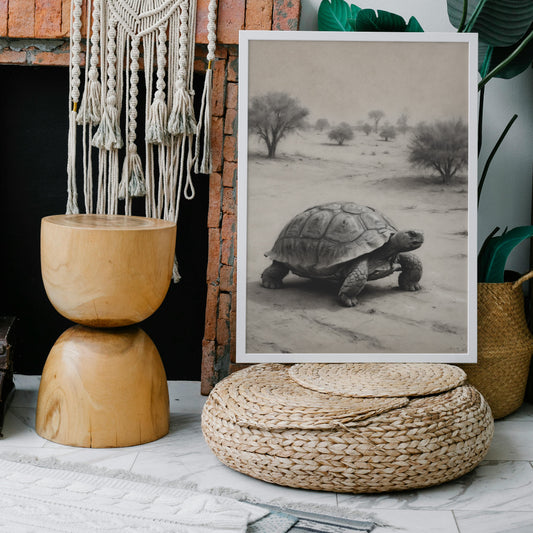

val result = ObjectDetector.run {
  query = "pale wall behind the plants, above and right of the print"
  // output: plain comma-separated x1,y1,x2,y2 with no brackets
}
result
300,0,533,272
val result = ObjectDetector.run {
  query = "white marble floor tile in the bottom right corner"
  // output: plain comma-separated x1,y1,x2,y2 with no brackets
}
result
454,511,533,533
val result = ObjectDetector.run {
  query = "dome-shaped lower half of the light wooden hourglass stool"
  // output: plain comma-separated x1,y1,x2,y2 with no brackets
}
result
36,325,169,448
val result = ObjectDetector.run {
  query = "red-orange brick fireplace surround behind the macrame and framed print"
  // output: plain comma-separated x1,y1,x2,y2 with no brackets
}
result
0,0,300,394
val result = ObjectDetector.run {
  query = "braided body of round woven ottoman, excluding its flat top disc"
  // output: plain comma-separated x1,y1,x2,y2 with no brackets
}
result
202,365,494,493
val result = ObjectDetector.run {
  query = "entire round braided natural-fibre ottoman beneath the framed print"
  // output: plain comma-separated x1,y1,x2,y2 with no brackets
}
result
202,363,494,493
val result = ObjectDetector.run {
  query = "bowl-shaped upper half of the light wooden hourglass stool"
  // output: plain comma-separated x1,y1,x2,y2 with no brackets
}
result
41,215,176,327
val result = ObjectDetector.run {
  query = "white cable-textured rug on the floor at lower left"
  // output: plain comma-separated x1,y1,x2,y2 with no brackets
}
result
0,459,275,533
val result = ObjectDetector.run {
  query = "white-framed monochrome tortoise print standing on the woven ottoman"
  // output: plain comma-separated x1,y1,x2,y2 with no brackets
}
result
236,31,477,363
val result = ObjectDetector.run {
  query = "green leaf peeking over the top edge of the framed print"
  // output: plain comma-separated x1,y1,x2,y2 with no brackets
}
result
318,0,424,32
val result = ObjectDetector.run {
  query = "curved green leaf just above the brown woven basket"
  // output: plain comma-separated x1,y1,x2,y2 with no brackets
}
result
478,226,533,283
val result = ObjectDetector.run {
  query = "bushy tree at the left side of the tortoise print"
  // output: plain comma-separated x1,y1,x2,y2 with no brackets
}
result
248,92,309,158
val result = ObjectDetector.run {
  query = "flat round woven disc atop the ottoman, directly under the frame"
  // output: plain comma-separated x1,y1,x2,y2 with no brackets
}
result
289,363,466,398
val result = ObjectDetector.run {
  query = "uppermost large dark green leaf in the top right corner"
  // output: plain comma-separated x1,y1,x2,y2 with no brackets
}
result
447,0,533,46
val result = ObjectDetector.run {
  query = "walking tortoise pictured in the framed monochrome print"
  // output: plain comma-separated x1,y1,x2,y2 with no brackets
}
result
261,202,424,307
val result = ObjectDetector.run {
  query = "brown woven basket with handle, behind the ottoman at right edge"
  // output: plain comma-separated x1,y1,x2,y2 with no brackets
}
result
459,272,533,418
